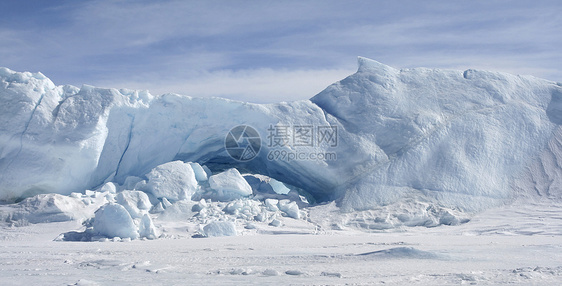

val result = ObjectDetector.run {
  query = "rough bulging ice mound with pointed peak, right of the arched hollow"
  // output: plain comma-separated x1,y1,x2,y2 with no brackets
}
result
312,58,562,209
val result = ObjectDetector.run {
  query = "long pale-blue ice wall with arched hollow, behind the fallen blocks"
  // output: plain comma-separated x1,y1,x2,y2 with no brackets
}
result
0,58,562,210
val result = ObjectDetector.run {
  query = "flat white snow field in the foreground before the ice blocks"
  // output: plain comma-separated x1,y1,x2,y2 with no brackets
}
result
0,200,562,285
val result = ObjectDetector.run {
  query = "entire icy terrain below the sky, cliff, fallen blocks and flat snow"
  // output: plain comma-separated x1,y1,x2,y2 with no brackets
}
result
0,58,562,285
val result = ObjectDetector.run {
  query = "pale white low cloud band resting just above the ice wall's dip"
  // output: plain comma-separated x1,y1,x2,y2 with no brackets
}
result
97,69,354,103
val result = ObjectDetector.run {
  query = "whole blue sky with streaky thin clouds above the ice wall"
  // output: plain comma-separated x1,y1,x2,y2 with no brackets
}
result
0,0,562,103
